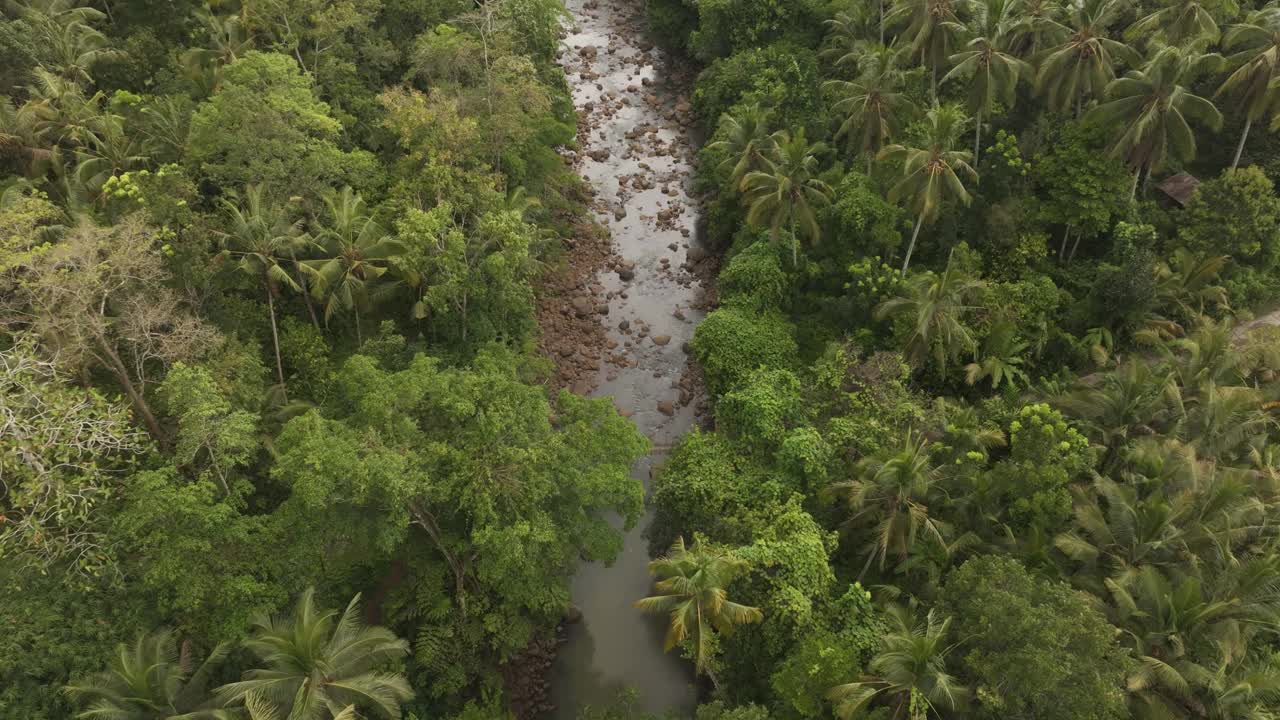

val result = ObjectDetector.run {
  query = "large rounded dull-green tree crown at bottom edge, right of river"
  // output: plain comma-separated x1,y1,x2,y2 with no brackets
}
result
945,556,1130,720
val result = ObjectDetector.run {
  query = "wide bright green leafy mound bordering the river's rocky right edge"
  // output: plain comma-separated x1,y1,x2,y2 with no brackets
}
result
692,302,796,392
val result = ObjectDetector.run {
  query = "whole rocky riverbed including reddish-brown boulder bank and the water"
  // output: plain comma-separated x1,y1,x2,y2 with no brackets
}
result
524,0,716,719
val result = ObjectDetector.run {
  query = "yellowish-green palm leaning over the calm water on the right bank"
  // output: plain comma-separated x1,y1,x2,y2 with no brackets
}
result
635,538,764,687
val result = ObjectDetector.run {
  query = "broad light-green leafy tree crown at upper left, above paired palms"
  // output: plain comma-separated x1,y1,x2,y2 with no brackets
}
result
187,51,378,197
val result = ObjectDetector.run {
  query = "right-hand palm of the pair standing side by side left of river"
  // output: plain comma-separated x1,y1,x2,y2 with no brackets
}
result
302,186,404,342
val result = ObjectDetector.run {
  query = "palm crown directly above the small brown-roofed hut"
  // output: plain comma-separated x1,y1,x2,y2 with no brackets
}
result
1088,47,1222,193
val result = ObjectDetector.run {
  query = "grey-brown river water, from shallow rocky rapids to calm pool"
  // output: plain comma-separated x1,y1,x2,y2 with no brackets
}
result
550,0,703,720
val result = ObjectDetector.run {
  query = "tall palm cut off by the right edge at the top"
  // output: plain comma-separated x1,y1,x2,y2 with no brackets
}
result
1213,1,1280,170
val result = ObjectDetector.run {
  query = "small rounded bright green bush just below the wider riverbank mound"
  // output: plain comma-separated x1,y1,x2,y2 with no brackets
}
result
716,366,804,448
